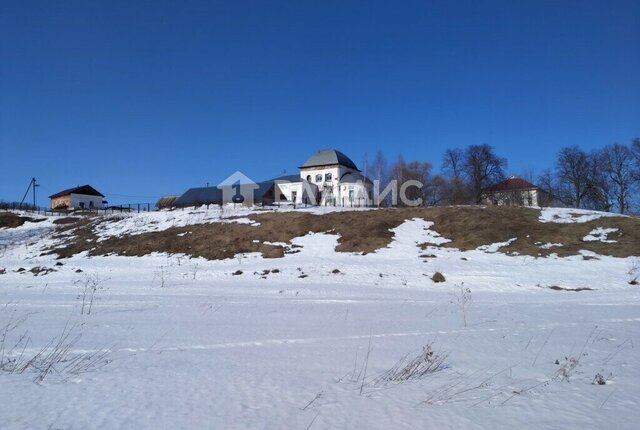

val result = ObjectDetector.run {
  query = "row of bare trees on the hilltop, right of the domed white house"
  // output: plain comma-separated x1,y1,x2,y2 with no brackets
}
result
363,138,640,213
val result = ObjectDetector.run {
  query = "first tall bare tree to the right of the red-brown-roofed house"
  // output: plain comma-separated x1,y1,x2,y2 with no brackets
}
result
556,146,591,208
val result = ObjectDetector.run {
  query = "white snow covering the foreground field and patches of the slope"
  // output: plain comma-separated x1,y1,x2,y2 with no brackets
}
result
0,209,640,429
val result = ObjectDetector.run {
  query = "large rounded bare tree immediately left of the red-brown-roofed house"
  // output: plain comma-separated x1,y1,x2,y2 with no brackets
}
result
462,144,507,203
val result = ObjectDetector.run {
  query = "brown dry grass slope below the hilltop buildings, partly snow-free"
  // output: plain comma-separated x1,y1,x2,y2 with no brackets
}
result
45,206,640,260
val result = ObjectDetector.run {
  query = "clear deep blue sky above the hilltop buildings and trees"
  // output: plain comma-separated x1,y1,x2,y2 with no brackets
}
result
0,0,640,204
